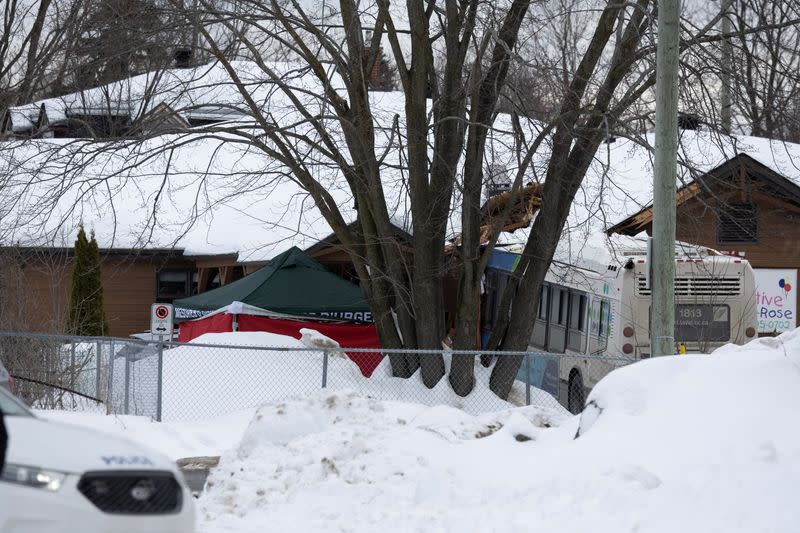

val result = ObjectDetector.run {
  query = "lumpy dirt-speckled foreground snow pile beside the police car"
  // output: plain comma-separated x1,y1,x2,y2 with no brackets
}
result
200,393,563,531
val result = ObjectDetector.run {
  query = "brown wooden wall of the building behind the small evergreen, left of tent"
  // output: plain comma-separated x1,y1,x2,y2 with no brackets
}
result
0,247,256,337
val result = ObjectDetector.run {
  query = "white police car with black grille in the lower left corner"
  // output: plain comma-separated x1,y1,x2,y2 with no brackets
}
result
0,389,195,533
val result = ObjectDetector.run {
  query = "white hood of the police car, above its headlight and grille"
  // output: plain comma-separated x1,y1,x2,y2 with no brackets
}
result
5,416,176,474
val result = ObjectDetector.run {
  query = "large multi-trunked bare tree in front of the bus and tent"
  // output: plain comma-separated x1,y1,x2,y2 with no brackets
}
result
3,0,788,397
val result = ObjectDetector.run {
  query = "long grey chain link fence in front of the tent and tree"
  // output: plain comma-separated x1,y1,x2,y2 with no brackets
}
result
0,332,633,420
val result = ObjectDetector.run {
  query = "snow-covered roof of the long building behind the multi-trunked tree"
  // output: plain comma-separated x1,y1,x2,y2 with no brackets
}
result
0,62,800,262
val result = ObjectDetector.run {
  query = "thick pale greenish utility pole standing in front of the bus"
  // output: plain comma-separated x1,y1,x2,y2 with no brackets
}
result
650,0,680,355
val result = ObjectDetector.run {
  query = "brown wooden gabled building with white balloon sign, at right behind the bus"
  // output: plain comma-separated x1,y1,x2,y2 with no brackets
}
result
608,154,800,334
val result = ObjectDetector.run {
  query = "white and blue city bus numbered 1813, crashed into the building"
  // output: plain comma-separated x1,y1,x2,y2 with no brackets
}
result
482,243,757,413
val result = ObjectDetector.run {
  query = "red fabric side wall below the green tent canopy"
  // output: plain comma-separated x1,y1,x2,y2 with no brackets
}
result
178,313,383,377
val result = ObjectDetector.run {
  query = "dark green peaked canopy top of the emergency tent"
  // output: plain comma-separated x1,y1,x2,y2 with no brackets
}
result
174,247,371,321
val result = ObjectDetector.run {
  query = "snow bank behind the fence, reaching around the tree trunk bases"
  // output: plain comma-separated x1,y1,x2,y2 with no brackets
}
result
136,330,536,421
